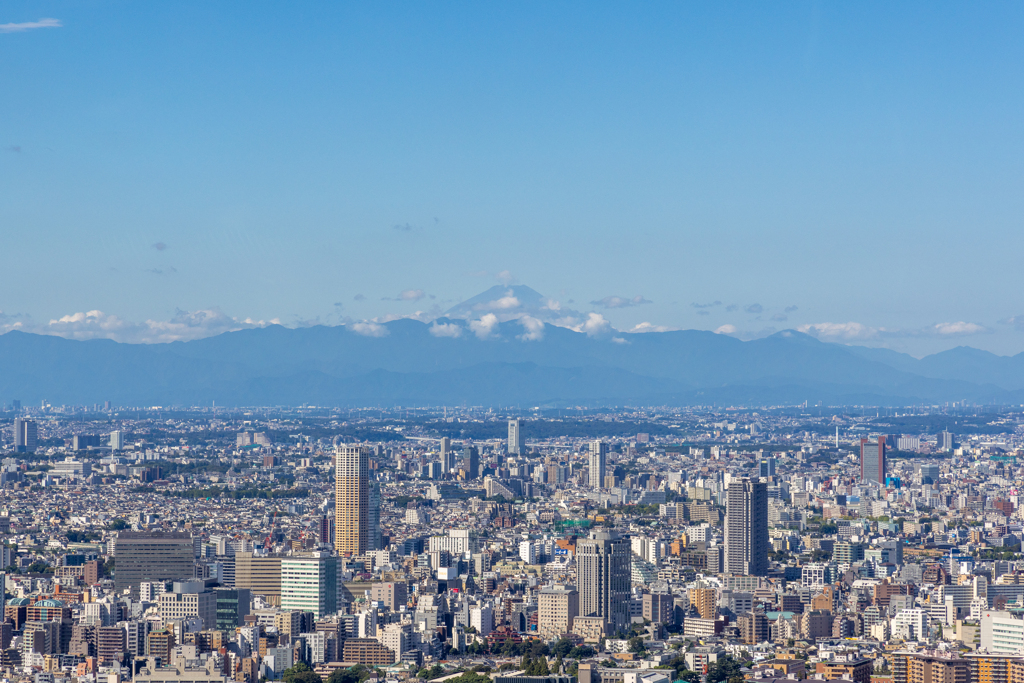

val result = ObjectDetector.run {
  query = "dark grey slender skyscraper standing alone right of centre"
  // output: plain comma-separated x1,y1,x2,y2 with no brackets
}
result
725,478,768,577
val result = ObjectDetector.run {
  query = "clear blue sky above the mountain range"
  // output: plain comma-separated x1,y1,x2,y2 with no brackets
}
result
0,2,1024,355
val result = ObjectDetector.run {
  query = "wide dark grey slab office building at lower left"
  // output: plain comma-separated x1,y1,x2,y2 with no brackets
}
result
114,531,196,598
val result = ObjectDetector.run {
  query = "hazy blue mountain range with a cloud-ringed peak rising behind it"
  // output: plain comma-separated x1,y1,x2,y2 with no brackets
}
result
0,288,1024,408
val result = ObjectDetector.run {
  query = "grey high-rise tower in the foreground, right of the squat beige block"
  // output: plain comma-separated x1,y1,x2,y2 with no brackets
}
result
577,529,630,634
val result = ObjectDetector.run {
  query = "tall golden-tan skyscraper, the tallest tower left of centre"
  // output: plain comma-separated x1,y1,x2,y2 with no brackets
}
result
334,445,370,555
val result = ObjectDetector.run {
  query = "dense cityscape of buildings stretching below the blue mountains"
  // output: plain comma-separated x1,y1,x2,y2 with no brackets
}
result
0,401,1024,683
